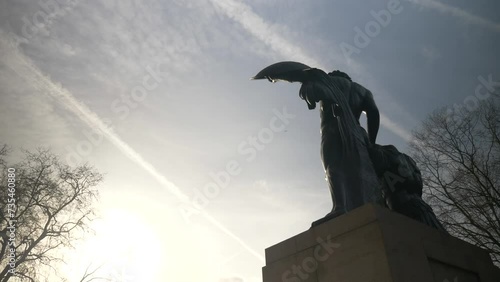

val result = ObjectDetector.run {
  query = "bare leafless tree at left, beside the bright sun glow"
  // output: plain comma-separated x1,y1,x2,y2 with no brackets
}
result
0,146,102,282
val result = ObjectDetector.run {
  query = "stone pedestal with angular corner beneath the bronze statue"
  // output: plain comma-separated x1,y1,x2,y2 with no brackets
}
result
262,205,500,282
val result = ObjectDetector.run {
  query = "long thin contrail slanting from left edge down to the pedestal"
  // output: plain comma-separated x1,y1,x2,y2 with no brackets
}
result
0,29,264,262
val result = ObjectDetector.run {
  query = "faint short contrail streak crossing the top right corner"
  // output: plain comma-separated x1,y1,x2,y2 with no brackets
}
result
407,0,500,32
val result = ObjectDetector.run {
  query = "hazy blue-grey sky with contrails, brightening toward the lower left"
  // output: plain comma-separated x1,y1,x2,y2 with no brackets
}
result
0,0,500,282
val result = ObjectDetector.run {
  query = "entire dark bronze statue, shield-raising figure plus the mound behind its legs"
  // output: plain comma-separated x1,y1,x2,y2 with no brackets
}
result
253,62,444,231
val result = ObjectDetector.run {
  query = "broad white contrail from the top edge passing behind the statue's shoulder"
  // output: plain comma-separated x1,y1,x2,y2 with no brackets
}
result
212,0,411,141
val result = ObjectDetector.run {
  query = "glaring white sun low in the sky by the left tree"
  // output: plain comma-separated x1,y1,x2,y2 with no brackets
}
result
60,208,163,282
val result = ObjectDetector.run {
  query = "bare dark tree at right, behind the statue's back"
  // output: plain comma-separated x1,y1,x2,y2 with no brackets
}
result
410,93,500,265
